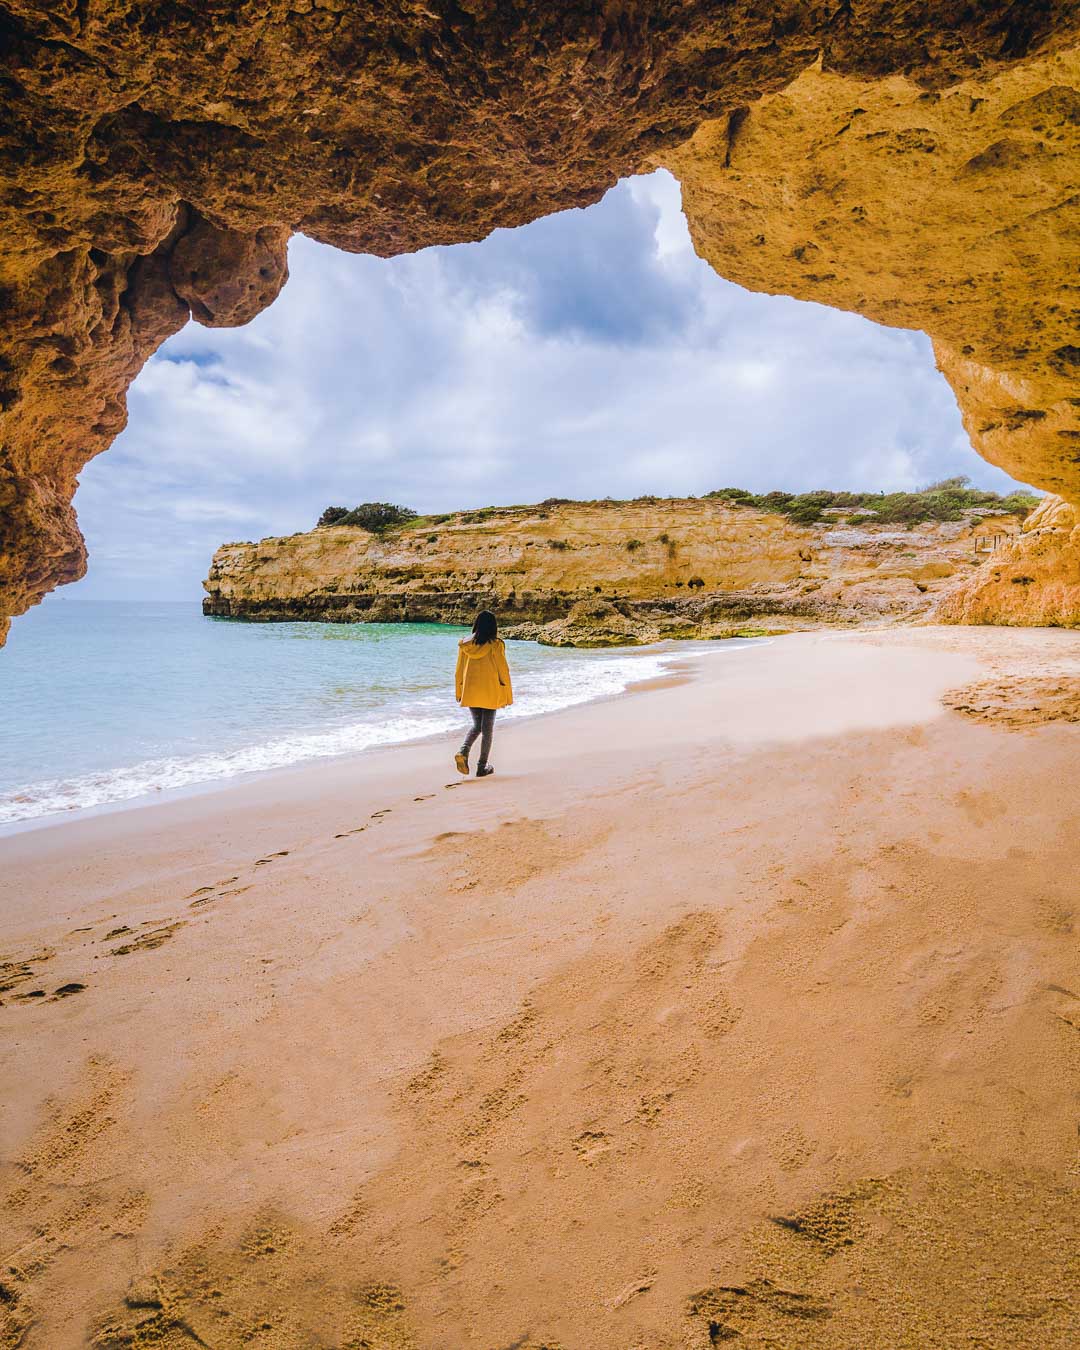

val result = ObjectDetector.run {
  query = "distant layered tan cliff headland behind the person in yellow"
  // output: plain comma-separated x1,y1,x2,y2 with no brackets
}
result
204,498,1019,645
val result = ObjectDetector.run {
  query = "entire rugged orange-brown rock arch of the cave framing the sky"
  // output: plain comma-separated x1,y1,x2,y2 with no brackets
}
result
0,0,1080,637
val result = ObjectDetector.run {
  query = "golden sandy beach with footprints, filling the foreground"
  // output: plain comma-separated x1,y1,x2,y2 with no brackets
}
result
0,629,1080,1350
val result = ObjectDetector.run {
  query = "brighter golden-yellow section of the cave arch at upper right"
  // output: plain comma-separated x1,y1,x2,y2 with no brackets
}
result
663,51,1080,501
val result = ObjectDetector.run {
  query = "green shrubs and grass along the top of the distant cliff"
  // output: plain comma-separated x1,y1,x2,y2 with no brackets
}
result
311,478,1040,531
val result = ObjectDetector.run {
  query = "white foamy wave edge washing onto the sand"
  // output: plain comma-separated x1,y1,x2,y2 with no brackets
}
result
0,637,772,848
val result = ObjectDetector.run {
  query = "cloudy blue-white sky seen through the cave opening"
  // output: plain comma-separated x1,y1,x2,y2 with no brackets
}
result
65,170,1031,599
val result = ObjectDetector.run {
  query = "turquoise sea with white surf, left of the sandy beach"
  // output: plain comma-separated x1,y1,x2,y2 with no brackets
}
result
0,598,691,825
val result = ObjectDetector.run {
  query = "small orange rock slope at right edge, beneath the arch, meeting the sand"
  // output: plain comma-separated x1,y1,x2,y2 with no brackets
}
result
940,497,1080,628
